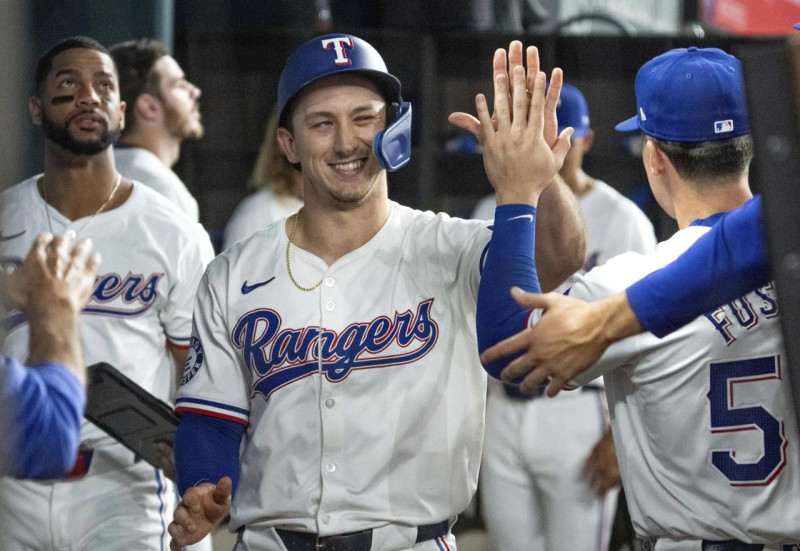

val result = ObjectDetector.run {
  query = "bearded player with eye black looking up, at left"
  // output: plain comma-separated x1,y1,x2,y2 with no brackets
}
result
0,37,213,551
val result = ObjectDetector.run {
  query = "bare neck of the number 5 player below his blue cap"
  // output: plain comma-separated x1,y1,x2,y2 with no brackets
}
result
673,172,753,229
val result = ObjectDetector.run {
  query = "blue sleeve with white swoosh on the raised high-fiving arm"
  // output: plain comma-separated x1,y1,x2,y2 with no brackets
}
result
476,205,541,378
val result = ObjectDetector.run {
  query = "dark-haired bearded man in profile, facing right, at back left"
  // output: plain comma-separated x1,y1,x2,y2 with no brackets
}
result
111,38,204,222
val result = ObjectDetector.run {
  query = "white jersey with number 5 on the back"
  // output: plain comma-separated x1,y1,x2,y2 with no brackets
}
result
544,222,800,550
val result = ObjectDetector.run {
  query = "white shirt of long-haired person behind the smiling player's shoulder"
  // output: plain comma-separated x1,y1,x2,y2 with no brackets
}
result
222,189,303,251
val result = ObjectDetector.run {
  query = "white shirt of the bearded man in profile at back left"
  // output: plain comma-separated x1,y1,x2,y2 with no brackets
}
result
114,146,200,222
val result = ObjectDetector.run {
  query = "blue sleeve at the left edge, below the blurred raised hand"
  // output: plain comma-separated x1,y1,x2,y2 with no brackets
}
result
2,358,86,479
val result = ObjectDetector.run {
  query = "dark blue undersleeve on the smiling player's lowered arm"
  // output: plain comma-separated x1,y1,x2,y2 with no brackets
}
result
174,413,244,495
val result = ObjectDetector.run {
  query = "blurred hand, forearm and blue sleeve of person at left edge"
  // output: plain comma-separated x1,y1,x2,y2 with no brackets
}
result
0,234,99,478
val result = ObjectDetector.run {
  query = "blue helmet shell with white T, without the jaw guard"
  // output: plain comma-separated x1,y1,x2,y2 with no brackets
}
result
278,33,402,126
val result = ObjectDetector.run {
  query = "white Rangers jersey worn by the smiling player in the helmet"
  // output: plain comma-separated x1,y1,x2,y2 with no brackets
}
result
176,203,491,551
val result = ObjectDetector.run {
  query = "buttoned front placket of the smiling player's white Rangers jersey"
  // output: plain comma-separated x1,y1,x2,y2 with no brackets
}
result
317,271,347,535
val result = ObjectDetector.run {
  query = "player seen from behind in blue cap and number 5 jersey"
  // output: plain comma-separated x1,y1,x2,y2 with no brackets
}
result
479,48,800,551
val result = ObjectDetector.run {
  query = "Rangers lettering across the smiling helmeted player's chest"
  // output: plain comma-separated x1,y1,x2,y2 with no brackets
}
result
231,298,439,399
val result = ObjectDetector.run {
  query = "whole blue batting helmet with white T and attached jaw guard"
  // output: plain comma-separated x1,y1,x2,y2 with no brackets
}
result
278,34,411,171
